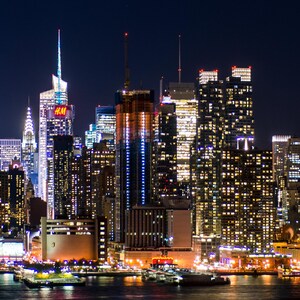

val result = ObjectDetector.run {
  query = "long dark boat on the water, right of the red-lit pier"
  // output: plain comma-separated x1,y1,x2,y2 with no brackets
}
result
178,273,230,286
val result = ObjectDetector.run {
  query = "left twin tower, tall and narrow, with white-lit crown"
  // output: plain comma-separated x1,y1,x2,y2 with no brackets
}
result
194,70,225,238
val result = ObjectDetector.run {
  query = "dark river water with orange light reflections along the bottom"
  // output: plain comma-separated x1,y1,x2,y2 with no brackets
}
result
0,274,300,300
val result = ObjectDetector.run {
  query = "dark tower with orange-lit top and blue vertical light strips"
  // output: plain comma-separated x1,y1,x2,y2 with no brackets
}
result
116,89,154,241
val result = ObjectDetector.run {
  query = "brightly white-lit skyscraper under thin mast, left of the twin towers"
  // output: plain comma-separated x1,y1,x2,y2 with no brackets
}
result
162,82,198,196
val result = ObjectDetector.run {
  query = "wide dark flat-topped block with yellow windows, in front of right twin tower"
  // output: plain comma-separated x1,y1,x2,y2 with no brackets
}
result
221,149,275,253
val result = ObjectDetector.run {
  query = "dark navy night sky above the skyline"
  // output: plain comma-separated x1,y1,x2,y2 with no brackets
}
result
0,0,300,148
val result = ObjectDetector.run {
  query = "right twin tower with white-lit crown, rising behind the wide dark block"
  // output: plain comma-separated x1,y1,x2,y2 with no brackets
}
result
225,66,254,149
